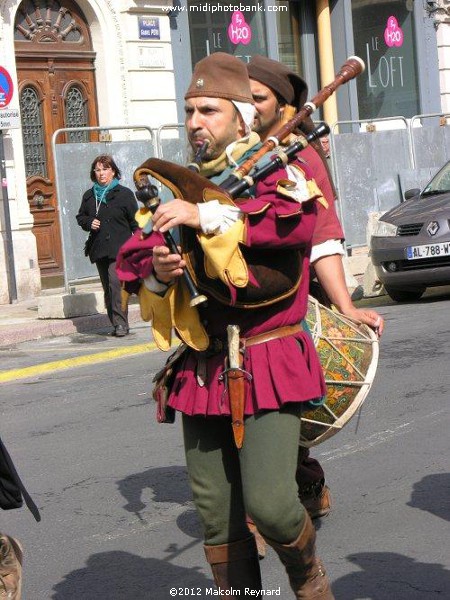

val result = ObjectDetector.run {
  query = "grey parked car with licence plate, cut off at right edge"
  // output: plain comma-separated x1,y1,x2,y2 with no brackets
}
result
370,161,450,302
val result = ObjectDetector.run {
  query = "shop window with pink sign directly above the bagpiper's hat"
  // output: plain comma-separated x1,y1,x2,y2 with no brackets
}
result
188,0,267,66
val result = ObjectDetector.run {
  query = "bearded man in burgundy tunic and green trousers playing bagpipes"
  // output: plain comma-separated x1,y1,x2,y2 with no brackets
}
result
117,53,333,600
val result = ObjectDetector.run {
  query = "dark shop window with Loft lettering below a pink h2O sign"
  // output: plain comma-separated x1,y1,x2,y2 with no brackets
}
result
352,0,420,119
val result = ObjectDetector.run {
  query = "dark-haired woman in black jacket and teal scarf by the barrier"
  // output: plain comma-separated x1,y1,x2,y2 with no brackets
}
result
77,154,138,337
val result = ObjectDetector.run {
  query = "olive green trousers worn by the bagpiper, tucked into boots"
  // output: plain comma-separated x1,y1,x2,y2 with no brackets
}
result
183,403,305,546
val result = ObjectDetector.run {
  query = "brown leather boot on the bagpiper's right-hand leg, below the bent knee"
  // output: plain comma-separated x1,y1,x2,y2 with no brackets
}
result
265,514,334,600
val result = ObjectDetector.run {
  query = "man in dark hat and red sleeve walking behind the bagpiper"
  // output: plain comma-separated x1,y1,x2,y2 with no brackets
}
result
247,55,384,554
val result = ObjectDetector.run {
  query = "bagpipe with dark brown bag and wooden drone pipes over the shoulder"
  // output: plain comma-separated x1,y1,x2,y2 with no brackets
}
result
134,57,364,309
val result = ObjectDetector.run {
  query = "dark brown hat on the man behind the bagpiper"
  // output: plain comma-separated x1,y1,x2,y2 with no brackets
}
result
247,54,308,109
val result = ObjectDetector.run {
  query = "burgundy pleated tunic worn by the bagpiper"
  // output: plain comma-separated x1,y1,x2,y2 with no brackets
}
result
117,164,326,416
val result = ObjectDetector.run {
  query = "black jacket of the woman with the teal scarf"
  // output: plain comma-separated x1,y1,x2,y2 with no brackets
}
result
77,184,138,263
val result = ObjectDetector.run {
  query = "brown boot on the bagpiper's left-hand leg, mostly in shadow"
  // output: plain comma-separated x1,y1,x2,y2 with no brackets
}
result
204,535,262,597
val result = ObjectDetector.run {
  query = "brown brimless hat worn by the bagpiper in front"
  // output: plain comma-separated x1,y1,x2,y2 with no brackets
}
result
184,52,254,104
